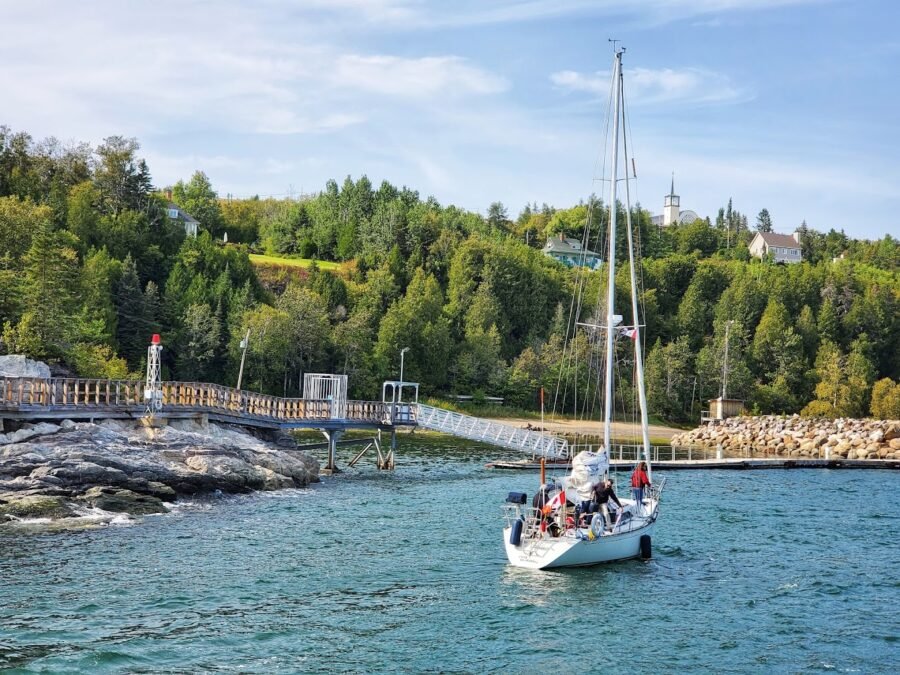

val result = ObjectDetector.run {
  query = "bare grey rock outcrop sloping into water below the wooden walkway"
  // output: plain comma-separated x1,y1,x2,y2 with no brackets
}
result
0,420,319,528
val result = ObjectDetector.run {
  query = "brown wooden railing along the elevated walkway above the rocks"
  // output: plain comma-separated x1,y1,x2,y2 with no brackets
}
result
0,377,400,424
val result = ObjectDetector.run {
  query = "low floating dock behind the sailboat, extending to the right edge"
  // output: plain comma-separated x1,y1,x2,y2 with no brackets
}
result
486,457,900,471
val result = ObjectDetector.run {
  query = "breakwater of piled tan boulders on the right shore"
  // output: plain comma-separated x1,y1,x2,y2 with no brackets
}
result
671,415,900,459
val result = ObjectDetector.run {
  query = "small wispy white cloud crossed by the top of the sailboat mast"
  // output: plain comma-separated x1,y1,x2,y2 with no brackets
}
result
550,68,752,105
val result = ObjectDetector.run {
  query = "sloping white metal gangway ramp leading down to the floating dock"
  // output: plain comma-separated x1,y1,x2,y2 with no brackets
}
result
416,403,569,459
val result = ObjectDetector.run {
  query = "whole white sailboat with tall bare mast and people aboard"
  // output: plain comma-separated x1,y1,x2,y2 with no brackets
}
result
503,49,665,569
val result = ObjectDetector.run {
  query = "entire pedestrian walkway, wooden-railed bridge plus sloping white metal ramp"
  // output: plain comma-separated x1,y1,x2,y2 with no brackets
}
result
0,377,568,457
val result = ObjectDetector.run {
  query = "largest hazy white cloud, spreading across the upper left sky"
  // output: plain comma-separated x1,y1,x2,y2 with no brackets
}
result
0,0,507,141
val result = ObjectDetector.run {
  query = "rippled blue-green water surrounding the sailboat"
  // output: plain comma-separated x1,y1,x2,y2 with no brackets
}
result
0,446,900,673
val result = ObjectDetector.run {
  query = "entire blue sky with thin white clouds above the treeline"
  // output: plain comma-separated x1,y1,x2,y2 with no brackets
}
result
0,0,900,239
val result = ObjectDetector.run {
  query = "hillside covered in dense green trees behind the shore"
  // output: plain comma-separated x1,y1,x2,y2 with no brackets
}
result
0,127,900,420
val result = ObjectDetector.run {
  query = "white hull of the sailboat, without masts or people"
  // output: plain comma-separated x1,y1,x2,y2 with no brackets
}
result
503,500,658,570
